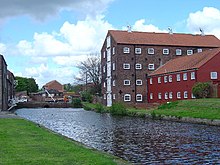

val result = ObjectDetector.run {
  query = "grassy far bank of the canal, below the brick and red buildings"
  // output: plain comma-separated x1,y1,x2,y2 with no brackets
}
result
83,99,220,120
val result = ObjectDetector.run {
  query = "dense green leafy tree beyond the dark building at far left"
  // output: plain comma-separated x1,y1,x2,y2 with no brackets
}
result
15,77,38,94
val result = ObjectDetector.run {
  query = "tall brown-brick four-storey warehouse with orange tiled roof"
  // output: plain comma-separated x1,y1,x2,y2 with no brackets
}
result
101,30,220,106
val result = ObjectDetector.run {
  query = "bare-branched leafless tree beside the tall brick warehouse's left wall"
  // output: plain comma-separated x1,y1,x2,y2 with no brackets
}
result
75,54,101,95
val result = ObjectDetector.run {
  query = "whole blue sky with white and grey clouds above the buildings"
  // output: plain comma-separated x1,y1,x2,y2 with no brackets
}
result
0,0,220,88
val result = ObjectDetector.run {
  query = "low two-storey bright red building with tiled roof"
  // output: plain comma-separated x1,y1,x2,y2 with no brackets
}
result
147,48,220,103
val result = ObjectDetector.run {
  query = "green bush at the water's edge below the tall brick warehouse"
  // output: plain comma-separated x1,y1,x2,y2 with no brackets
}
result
110,102,127,116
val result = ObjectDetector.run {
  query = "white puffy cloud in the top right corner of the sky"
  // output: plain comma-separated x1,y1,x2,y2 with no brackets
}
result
187,7,220,38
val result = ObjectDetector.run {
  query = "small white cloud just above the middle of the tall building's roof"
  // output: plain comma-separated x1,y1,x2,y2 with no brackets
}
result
123,19,167,33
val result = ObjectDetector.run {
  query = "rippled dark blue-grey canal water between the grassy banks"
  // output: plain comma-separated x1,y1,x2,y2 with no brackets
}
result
16,108,220,164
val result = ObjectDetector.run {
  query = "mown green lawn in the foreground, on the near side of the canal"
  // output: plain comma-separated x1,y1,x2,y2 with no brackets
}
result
0,119,128,165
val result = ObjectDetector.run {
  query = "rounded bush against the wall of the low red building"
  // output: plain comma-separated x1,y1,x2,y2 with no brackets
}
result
192,82,211,98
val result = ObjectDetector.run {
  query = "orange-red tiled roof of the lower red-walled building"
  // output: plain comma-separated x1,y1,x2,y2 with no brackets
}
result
149,48,220,76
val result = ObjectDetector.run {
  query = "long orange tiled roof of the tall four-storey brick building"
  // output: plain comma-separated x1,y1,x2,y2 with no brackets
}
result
109,30,220,48
